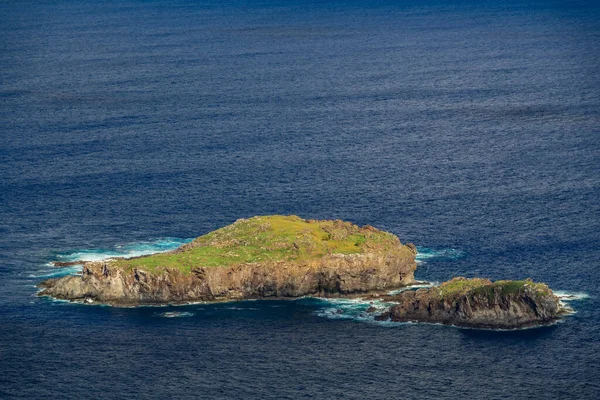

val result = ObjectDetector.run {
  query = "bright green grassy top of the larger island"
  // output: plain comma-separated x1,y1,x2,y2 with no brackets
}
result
113,215,400,273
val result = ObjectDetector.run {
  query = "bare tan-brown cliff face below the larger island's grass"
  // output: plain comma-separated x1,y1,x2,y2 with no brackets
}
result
39,254,416,307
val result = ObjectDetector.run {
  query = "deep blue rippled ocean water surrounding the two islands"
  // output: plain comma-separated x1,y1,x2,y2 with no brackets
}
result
0,0,600,399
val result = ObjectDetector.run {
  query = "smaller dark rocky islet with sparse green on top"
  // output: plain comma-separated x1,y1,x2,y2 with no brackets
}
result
377,277,563,329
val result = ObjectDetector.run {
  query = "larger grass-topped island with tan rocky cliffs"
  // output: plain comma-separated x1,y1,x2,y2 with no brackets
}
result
40,216,416,306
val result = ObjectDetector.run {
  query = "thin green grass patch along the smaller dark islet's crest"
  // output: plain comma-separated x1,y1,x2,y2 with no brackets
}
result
437,277,551,298
